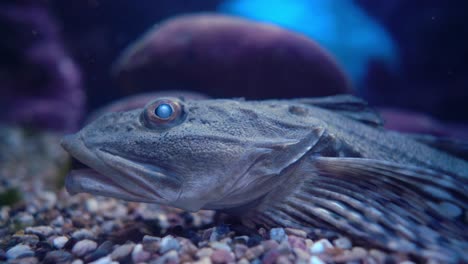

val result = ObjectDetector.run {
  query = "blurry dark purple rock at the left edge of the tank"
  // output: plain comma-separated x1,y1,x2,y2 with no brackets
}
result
0,1,84,131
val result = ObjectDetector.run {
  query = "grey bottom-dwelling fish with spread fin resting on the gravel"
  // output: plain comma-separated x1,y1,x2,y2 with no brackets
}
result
62,95,468,263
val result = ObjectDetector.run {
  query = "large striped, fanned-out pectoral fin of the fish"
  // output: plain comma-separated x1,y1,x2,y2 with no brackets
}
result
252,157,468,261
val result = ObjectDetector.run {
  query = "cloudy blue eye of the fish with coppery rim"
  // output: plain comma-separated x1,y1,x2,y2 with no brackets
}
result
142,99,184,128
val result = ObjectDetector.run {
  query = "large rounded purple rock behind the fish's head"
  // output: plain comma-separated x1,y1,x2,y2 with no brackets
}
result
114,14,350,99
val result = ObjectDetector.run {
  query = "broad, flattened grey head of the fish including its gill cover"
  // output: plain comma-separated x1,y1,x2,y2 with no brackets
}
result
62,98,320,211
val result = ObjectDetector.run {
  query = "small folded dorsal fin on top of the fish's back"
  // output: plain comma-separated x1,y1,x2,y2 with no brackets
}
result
294,94,384,127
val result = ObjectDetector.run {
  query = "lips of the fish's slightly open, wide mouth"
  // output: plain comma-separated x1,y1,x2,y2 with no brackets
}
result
61,134,164,203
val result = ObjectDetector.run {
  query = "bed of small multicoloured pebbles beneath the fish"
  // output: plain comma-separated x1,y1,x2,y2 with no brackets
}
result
0,190,411,264
